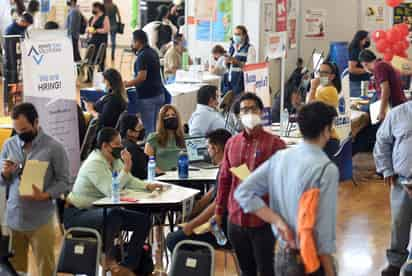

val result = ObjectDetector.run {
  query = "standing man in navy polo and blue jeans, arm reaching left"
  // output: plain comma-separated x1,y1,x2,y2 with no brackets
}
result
125,30,165,133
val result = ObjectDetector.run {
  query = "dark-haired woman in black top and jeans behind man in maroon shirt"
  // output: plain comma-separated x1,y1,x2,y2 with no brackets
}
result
348,31,371,97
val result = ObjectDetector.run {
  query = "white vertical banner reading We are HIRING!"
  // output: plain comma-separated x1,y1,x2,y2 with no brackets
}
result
21,31,80,176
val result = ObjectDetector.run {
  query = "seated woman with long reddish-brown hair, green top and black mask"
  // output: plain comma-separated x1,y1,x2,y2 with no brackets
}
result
144,105,186,172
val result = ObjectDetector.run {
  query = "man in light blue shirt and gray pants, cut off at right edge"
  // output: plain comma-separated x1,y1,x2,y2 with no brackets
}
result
373,102,412,276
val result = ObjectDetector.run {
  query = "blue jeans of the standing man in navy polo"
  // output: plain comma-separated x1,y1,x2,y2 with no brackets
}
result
139,93,165,134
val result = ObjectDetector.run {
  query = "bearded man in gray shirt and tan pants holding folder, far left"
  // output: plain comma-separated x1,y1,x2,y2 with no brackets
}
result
0,103,70,275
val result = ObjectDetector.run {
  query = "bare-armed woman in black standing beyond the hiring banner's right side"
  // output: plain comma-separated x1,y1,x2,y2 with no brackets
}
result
87,2,110,72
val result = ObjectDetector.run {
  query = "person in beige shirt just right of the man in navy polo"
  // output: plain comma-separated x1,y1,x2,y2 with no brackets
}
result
164,34,186,79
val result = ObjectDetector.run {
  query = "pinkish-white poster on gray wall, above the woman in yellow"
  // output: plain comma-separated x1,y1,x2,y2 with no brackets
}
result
304,9,326,39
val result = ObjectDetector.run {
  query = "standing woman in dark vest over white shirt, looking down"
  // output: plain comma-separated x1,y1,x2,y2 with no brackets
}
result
222,26,257,96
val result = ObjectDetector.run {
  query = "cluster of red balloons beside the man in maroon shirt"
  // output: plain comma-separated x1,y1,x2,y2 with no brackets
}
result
371,23,410,61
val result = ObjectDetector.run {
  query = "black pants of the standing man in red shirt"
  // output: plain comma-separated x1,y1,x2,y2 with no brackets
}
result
228,222,275,276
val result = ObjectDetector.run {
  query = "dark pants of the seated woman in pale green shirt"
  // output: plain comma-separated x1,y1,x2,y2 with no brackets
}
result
64,208,150,270
